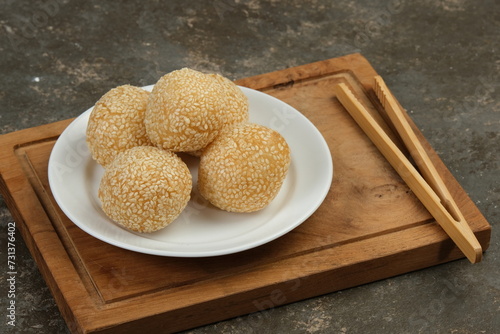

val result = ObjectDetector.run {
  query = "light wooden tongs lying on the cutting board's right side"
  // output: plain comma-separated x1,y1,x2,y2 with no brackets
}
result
334,76,482,263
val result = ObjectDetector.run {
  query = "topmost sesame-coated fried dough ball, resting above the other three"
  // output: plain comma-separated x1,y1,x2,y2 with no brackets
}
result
145,68,248,152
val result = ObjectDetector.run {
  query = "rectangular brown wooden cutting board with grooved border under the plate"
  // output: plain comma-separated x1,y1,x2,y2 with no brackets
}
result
0,54,491,333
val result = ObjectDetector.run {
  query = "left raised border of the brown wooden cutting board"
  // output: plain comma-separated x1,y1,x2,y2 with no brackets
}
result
0,136,97,333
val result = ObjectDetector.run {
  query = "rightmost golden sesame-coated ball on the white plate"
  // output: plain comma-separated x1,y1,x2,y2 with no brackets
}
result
198,123,290,212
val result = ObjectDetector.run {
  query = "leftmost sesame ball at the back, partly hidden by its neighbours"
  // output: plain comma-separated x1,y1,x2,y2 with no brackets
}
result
87,85,152,166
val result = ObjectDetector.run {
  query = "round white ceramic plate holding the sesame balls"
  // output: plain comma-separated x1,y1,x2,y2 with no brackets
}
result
48,86,333,257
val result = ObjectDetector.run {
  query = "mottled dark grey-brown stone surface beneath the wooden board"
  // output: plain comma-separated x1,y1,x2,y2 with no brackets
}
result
0,0,500,334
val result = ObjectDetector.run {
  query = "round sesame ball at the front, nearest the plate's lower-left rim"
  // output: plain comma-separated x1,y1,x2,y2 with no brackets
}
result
98,146,192,232
